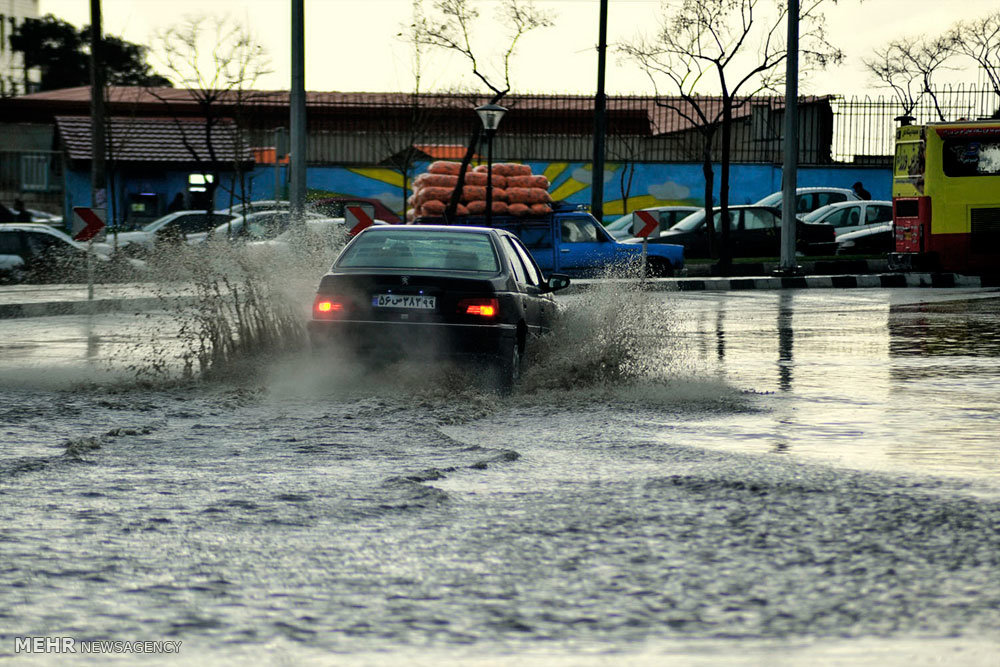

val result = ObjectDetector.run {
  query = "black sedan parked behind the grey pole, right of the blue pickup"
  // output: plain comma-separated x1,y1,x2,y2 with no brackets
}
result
626,204,836,259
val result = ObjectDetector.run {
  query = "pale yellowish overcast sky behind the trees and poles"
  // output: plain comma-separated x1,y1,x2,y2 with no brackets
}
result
39,0,998,99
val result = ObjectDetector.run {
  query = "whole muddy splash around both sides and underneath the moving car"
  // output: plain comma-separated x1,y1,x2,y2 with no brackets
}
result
101,228,736,414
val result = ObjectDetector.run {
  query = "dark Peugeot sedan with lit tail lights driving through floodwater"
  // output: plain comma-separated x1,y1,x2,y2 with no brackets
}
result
308,225,569,391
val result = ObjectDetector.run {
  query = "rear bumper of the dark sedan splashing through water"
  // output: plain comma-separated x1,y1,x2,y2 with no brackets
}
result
307,320,517,358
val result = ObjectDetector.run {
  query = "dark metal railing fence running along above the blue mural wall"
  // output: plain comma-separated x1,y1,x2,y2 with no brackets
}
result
268,86,1000,165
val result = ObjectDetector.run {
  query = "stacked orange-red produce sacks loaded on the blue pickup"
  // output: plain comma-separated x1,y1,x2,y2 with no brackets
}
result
407,161,552,220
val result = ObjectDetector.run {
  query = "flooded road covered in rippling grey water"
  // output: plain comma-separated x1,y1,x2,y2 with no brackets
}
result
0,288,1000,665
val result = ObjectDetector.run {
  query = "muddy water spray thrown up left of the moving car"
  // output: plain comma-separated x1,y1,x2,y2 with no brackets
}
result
113,225,345,381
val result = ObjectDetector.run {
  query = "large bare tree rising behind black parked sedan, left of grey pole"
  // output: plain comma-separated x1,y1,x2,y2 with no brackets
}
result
618,0,843,272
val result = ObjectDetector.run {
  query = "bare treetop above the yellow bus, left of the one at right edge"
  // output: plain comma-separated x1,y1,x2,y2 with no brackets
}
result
862,35,956,120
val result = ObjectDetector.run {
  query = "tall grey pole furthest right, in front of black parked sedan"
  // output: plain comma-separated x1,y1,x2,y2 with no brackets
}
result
778,0,799,275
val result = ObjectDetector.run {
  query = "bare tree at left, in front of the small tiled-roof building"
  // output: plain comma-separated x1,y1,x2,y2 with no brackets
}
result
150,14,271,222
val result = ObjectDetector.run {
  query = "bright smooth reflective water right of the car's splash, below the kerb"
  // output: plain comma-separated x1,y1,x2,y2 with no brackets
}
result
678,289,1000,478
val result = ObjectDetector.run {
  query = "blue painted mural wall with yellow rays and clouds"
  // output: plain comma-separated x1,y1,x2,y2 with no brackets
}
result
242,162,892,219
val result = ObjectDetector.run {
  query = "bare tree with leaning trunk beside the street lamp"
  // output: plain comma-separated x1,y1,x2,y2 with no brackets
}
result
413,0,552,218
